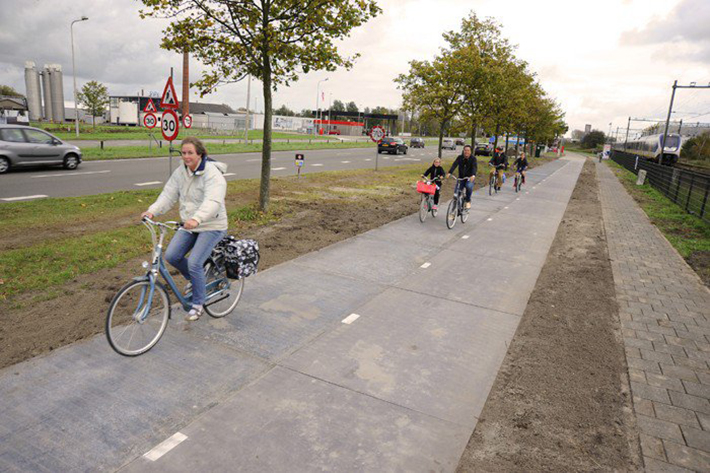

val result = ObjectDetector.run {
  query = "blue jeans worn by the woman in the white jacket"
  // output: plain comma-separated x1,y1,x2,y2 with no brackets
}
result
165,229,227,306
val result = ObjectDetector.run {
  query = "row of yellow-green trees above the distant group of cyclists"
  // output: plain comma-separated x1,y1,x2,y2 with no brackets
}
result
395,12,568,156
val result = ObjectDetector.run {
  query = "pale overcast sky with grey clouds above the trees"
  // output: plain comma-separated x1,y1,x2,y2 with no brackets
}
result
0,0,710,136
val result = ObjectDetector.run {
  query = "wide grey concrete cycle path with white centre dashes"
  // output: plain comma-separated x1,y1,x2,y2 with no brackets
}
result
0,157,583,472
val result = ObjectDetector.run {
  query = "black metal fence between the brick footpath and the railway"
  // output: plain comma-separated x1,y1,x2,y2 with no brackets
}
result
611,150,710,223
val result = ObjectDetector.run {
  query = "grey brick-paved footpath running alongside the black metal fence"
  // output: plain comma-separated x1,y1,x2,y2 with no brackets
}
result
597,161,710,471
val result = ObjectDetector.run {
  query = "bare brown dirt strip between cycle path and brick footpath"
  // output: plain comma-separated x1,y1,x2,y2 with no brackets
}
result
458,160,640,472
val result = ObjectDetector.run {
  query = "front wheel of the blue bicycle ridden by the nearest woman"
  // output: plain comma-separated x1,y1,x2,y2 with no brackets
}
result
106,281,170,356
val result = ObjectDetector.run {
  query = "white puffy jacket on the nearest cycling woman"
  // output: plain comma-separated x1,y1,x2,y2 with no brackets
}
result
148,156,228,232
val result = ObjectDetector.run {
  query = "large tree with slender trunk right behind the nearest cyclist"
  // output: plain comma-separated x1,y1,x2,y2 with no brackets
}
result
141,0,381,211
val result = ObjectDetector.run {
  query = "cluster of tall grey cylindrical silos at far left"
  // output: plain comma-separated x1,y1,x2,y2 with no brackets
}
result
25,61,65,123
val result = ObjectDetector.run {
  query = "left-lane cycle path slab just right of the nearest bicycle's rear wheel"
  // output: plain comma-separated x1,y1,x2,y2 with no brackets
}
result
192,263,384,360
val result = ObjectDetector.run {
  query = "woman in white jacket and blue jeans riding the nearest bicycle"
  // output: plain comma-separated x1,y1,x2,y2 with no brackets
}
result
141,136,227,321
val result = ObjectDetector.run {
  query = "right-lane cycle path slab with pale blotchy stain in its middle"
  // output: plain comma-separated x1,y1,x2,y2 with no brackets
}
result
284,288,519,430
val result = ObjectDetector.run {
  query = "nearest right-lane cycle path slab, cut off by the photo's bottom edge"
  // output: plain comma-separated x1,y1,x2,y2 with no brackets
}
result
121,368,470,473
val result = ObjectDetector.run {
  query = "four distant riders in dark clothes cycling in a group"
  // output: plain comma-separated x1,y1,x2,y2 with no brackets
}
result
422,145,528,210
